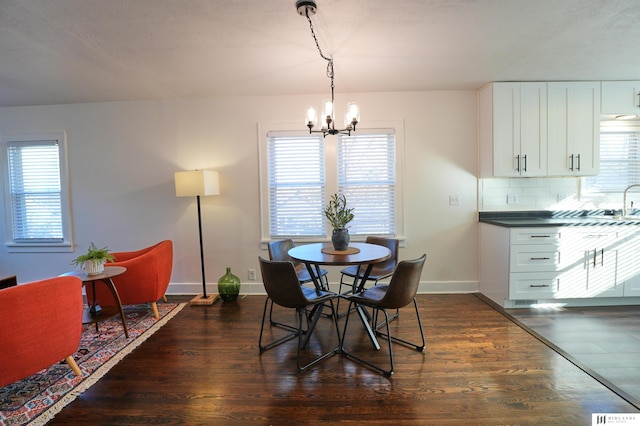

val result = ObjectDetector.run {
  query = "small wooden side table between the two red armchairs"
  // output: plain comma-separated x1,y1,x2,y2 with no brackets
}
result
62,266,129,338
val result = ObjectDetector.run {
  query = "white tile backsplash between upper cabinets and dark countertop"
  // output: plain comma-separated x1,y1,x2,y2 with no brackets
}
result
478,177,628,211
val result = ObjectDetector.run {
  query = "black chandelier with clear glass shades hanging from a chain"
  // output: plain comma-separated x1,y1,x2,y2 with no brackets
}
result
296,0,360,137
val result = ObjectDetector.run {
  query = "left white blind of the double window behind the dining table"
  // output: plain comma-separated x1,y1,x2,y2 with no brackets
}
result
267,133,325,237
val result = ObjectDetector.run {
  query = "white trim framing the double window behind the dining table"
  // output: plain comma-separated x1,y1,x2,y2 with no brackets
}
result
258,120,405,248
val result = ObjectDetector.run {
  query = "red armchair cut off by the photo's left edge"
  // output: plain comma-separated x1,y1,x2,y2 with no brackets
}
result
0,277,83,388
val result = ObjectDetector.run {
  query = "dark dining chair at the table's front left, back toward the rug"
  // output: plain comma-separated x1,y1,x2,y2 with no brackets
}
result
258,257,340,373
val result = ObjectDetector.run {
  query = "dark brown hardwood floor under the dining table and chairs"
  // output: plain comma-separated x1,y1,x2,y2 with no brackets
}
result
50,294,638,425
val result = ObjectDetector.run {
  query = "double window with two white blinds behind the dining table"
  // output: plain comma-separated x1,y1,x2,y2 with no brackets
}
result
261,124,403,241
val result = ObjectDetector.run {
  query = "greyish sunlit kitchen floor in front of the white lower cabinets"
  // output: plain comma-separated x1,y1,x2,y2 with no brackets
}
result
506,306,640,407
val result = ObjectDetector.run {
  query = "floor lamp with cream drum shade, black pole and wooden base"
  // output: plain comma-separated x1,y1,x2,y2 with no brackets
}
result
175,170,220,305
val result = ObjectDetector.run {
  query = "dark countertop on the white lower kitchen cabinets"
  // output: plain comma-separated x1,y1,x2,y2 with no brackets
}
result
478,210,640,228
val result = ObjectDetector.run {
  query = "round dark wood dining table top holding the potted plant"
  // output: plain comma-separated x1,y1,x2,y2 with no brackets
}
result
289,243,391,265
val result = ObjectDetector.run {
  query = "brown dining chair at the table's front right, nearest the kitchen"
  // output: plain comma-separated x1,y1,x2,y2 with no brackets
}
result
340,254,427,376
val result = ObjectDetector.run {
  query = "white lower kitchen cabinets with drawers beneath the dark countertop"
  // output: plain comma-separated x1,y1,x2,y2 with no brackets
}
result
480,223,640,307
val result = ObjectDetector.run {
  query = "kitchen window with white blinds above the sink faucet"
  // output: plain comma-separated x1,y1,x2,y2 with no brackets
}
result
585,128,640,193
